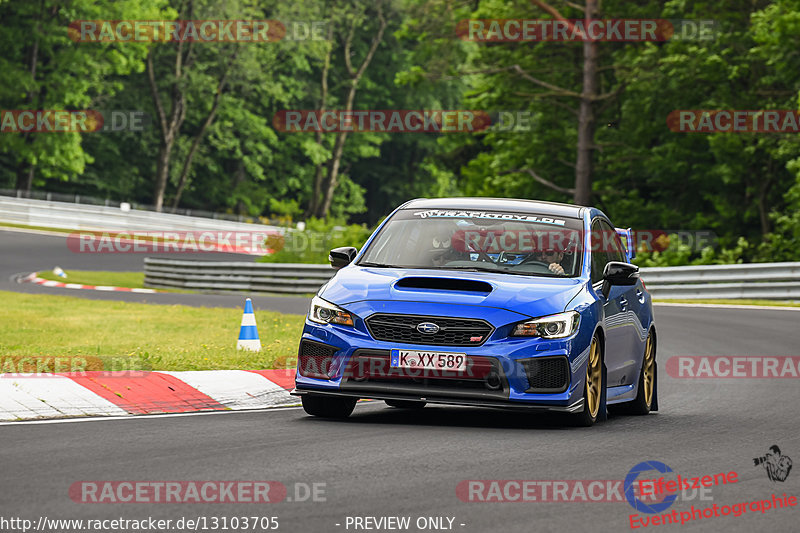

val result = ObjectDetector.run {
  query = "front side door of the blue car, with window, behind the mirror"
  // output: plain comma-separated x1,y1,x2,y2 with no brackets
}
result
599,219,643,387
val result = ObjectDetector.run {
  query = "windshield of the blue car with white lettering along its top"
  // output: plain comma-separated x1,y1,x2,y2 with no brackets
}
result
358,209,583,277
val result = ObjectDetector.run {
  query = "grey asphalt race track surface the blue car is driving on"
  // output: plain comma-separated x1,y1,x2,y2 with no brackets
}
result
0,227,800,532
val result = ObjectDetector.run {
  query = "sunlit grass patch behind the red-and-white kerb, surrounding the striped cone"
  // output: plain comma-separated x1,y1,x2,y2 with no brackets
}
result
0,291,304,370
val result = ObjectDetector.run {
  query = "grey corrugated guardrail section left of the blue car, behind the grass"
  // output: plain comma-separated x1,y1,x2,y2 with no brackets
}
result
144,257,336,294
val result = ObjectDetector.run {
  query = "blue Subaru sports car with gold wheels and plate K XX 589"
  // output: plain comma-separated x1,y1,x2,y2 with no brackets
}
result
293,198,658,426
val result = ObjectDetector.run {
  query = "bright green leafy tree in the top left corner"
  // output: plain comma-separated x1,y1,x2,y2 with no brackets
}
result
0,0,168,190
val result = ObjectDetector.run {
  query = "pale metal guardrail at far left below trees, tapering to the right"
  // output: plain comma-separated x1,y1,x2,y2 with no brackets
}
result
0,195,283,233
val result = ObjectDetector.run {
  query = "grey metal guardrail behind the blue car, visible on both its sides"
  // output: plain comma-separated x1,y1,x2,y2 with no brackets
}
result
145,258,800,300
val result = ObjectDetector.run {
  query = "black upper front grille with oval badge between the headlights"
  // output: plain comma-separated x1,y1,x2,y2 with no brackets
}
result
365,313,494,346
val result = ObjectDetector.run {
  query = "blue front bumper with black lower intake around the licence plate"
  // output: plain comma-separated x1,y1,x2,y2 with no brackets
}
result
292,314,591,412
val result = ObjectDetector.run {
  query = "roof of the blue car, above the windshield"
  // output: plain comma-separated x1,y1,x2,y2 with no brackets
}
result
400,197,586,218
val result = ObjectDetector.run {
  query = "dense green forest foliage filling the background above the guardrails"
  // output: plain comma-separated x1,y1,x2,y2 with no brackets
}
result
0,0,800,265
